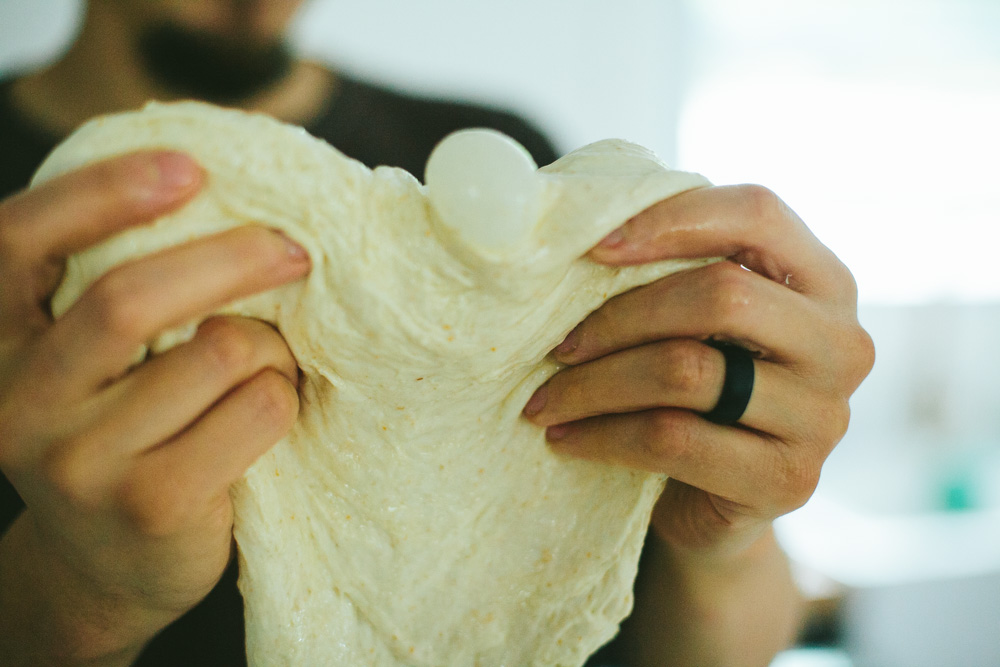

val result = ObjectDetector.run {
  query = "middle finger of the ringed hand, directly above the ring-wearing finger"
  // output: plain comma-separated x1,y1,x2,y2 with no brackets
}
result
554,262,833,365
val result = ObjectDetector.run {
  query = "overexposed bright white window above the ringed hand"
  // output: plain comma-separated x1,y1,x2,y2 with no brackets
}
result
679,0,1000,303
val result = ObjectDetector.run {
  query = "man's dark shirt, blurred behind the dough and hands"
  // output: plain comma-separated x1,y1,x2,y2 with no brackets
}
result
0,77,557,667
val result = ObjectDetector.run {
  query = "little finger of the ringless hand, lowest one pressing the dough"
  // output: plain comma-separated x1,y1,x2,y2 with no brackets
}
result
120,369,298,534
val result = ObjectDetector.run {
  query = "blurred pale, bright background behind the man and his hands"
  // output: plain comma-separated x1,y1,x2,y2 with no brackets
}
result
0,0,1000,667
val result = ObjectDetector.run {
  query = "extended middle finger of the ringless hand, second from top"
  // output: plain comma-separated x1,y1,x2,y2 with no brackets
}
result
40,227,309,390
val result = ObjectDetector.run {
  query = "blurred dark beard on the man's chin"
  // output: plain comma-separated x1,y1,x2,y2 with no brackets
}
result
139,24,294,104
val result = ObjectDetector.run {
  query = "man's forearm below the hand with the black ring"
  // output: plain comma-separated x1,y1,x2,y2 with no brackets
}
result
614,531,802,667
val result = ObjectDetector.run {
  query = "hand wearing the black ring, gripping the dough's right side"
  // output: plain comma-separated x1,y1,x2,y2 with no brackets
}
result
526,186,874,557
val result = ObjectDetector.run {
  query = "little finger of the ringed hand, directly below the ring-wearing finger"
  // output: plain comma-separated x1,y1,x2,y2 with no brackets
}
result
548,409,825,516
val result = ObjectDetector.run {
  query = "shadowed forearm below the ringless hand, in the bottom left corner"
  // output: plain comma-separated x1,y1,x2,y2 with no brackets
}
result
0,514,152,667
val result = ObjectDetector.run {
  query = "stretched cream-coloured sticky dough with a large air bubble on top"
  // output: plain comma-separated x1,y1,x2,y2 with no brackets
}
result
35,103,706,667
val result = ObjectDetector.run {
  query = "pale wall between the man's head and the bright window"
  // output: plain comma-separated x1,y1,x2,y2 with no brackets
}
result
299,0,684,159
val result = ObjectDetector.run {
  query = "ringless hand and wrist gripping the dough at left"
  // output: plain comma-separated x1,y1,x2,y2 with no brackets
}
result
0,152,309,664
